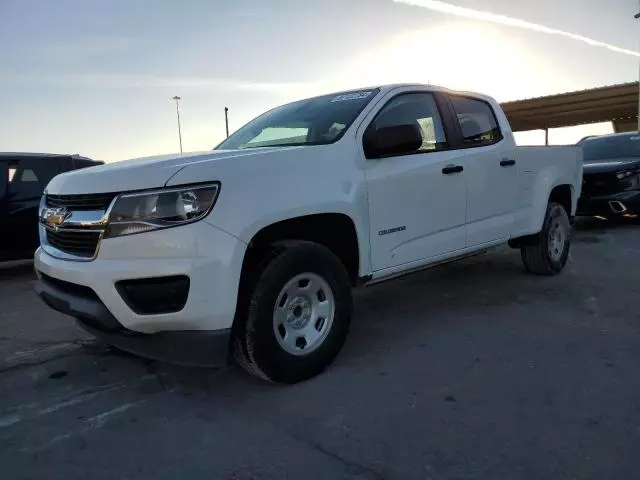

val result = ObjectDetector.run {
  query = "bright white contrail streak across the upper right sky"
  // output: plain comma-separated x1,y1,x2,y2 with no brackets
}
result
392,0,640,57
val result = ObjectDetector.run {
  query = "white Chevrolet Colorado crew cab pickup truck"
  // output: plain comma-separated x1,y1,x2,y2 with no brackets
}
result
35,85,582,383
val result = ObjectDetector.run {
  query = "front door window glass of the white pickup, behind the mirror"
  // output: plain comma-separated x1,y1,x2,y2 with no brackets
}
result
373,93,447,152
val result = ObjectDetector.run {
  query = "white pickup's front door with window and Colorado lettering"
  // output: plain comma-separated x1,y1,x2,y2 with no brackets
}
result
365,91,467,271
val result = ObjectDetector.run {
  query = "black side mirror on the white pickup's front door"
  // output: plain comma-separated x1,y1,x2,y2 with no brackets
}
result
364,124,422,158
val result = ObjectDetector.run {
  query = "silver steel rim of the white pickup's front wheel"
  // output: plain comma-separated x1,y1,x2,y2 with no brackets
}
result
273,273,335,356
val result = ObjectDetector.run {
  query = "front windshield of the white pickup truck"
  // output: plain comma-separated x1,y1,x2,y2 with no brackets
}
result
215,89,379,150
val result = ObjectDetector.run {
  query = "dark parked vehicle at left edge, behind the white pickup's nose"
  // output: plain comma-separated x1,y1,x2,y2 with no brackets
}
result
0,153,103,261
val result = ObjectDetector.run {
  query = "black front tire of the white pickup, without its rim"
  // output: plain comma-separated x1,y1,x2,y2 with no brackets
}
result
233,241,352,384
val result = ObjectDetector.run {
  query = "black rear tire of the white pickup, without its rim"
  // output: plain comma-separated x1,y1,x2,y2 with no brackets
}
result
520,202,571,275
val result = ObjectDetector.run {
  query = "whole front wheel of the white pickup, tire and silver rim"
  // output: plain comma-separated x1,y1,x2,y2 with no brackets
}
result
234,241,352,383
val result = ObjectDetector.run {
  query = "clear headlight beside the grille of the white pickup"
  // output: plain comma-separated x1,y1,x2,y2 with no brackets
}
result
105,183,220,237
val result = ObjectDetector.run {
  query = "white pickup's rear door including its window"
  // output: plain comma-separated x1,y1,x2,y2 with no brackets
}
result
449,95,518,247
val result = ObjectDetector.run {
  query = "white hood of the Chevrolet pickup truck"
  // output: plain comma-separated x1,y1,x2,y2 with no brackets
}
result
46,147,299,195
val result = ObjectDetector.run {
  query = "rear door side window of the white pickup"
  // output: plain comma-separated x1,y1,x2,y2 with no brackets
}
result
450,96,502,146
